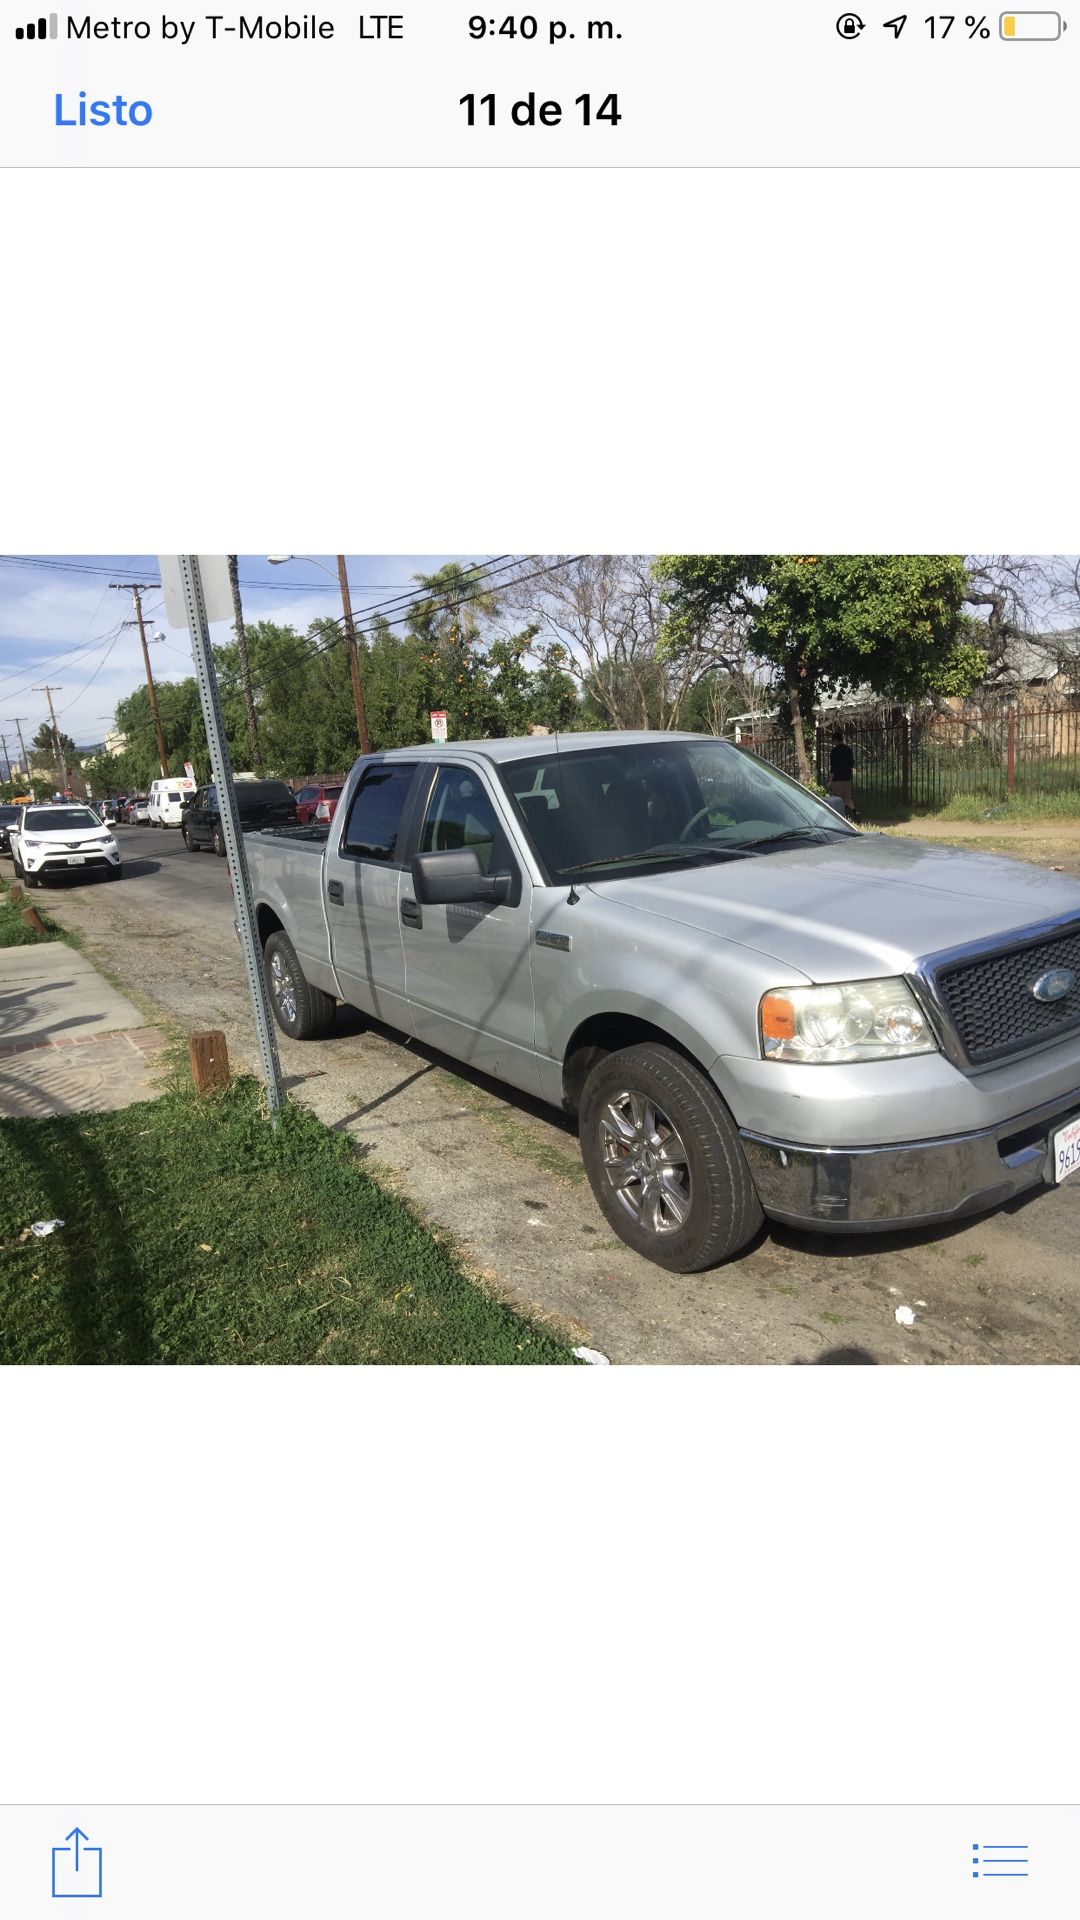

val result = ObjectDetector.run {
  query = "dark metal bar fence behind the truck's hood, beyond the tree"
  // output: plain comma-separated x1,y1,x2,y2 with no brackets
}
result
742,703,1080,812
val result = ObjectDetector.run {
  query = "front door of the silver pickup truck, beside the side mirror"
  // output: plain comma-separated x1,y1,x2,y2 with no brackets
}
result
402,758,540,1092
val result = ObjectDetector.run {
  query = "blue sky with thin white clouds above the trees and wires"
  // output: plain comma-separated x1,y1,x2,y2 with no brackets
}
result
0,553,480,760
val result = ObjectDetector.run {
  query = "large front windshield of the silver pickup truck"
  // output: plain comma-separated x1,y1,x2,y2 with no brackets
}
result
500,739,853,879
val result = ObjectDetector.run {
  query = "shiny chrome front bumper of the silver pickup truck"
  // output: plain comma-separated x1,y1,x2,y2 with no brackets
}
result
742,1089,1080,1233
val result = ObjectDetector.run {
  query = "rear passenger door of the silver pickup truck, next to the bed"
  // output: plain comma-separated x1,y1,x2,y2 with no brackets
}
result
323,760,419,1033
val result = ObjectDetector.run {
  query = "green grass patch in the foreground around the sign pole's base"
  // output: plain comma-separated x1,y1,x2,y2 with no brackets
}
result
0,1079,573,1365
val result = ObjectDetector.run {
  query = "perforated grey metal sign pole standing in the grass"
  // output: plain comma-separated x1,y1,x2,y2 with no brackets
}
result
177,553,284,1119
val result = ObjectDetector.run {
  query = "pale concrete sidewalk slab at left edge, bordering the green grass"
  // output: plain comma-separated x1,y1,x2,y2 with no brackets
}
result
0,941,165,1119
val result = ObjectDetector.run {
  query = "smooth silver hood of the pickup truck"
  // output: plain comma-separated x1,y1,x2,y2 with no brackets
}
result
590,833,1080,985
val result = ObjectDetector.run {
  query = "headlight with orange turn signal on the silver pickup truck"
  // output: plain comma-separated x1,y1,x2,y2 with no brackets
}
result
759,979,938,1066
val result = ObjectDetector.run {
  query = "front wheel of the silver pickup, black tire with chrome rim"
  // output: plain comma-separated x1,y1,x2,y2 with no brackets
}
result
578,1041,763,1273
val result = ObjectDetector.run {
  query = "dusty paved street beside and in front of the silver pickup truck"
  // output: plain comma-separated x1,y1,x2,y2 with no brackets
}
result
27,828,1080,1365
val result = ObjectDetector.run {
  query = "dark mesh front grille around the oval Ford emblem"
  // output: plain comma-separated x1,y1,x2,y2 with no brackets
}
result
936,925,1080,1066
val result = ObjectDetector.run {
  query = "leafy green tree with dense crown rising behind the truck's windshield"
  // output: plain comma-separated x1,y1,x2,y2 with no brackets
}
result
655,553,986,781
